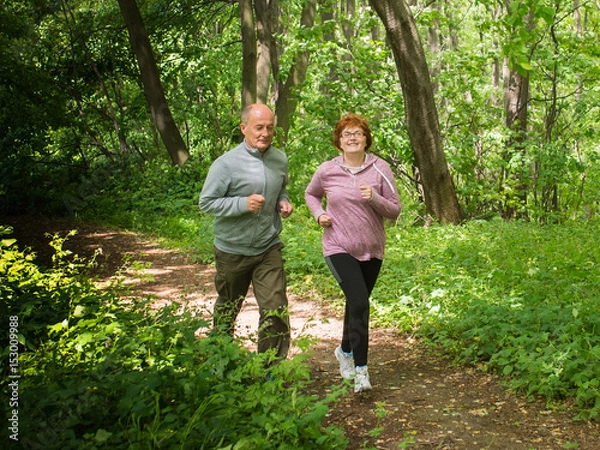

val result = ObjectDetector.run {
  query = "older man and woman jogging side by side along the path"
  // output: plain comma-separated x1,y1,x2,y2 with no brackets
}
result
199,104,400,393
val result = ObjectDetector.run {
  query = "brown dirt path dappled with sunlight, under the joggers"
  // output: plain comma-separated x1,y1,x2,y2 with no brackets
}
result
0,217,600,450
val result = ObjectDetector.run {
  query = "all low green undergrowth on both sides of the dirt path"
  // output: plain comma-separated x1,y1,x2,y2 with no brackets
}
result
1,156,600,434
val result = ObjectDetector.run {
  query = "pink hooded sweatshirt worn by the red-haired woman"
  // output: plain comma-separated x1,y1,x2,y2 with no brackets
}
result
304,153,401,261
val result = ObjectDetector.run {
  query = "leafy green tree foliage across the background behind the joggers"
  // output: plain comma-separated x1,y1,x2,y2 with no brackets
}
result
0,0,600,223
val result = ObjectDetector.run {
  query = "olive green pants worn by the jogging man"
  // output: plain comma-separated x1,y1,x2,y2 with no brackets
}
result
213,244,290,359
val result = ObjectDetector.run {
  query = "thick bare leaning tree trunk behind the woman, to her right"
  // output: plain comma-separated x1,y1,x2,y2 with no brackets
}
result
369,0,461,224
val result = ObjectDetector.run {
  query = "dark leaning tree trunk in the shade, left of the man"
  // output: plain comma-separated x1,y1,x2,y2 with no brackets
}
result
119,0,190,166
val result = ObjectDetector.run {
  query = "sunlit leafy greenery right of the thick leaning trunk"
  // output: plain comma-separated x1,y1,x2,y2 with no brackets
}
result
426,1,600,223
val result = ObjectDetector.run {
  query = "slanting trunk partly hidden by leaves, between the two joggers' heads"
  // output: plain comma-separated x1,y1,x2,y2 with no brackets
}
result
275,0,317,142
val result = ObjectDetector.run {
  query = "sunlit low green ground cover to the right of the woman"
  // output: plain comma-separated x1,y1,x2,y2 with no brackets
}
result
373,220,600,418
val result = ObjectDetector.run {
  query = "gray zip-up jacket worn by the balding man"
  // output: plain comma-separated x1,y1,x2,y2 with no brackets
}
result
199,141,289,255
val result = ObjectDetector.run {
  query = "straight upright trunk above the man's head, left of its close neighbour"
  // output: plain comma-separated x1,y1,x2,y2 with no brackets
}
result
240,0,257,110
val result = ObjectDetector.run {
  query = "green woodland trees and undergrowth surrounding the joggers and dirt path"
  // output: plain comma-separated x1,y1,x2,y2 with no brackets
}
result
0,0,600,448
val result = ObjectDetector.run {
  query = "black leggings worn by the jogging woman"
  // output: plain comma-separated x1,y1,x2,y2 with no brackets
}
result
325,253,382,366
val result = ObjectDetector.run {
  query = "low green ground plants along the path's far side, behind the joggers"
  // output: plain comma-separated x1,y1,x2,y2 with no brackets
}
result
30,152,600,417
